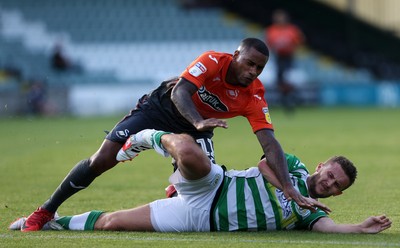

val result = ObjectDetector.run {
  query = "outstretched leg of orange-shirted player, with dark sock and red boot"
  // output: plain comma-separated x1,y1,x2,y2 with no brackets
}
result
21,110,155,232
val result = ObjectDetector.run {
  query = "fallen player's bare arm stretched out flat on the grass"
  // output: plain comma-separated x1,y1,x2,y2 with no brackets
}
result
312,215,392,234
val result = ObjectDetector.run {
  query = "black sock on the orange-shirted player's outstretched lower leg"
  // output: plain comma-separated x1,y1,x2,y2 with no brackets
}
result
42,159,98,213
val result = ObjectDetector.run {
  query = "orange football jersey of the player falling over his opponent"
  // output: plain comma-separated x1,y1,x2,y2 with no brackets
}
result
181,51,273,132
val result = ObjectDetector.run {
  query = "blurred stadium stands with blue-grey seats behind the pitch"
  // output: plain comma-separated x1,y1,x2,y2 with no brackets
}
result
0,0,400,117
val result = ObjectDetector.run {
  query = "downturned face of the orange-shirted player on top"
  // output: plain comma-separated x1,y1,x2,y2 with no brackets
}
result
230,48,268,87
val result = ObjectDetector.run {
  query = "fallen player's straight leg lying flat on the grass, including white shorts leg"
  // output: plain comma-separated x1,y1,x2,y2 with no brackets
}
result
45,198,188,232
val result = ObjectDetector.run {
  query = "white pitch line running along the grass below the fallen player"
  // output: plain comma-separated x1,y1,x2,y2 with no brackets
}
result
0,234,400,247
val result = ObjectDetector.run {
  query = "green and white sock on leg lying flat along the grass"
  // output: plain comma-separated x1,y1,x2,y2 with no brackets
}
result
56,210,103,231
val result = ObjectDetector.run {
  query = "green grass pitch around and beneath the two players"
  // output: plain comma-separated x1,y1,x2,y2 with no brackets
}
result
0,108,400,248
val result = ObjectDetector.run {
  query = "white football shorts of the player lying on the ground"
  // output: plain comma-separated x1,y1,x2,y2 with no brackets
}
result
150,164,224,232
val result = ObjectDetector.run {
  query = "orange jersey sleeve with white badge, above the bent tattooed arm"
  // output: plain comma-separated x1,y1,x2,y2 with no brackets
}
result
181,51,224,88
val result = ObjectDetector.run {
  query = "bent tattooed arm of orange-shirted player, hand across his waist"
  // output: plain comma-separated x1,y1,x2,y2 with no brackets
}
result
171,78,228,131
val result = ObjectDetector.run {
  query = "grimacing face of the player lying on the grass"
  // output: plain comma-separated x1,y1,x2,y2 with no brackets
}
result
307,162,350,198
